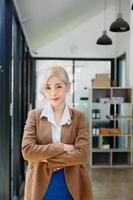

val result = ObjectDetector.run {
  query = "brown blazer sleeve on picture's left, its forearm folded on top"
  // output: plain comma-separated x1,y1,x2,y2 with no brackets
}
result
22,110,64,162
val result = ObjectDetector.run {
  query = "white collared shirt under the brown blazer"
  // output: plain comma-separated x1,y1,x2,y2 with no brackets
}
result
40,102,71,143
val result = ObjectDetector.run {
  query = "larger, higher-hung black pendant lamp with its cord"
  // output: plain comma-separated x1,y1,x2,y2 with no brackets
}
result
110,0,130,32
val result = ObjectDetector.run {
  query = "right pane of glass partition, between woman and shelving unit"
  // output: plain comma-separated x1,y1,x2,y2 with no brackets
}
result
74,61,111,119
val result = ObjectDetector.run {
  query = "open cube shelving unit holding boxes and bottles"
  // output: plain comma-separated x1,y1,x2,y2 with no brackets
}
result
89,87,133,167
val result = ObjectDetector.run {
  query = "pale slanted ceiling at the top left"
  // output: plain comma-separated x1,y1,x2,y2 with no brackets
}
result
14,0,116,52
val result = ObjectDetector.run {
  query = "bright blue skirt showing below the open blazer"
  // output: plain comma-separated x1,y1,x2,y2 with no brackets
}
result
43,169,73,200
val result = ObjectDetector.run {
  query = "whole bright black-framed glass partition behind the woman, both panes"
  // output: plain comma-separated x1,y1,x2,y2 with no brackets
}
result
36,59,111,121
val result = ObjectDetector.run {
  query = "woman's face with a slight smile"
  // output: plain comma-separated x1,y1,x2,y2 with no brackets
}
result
44,76,70,107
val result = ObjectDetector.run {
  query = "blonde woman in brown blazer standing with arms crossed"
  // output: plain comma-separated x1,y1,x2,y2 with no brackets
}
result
22,66,92,200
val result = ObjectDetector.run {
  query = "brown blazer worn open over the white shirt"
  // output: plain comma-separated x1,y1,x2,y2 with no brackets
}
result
22,109,93,200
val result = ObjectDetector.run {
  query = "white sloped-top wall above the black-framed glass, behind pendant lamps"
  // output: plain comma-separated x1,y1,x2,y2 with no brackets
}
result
38,7,115,57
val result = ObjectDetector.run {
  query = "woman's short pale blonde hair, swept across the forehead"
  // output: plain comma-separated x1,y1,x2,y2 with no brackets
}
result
41,66,70,95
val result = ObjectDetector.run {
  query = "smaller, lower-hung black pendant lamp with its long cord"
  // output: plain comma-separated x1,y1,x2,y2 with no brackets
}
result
96,0,112,45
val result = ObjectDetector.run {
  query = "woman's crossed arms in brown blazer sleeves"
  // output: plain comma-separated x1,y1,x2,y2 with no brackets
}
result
22,111,89,168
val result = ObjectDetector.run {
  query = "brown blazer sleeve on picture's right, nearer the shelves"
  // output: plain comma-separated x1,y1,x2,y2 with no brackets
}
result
48,113,89,168
